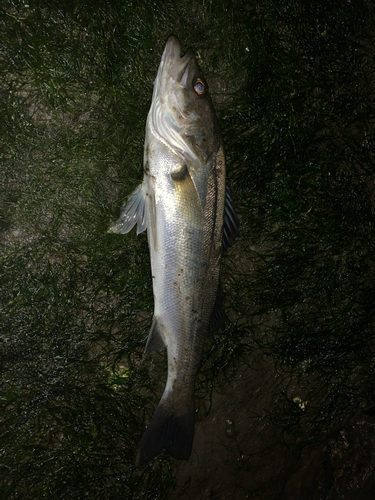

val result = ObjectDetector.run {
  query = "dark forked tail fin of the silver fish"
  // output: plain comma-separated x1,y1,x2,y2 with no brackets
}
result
135,391,194,466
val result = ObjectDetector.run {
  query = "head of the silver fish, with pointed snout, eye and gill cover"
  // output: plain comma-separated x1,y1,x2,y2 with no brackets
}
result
149,36,221,168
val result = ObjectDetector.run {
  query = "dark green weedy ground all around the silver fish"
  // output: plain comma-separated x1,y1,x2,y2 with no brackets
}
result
0,0,375,500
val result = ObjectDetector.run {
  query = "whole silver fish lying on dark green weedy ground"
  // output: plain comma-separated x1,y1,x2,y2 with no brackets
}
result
110,35,239,466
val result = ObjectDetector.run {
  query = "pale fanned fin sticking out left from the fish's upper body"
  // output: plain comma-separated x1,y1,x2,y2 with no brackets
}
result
108,183,149,234
